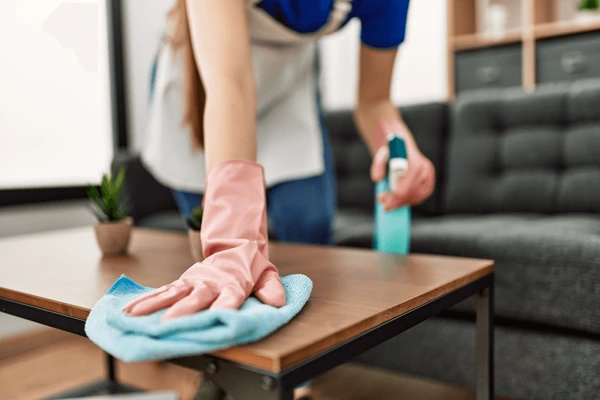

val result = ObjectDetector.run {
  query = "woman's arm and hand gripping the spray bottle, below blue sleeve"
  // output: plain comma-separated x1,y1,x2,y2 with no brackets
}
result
355,45,435,210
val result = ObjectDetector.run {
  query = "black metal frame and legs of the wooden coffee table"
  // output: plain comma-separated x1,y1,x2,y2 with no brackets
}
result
0,273,494,400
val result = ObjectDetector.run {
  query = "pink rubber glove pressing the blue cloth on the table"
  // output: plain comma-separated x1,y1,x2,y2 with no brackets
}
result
123,160,286,321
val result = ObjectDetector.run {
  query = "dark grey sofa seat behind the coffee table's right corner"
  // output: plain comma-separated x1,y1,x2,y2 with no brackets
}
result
334,210,600,334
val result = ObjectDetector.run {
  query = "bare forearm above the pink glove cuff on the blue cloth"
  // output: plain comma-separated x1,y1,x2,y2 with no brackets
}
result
187,0,257,171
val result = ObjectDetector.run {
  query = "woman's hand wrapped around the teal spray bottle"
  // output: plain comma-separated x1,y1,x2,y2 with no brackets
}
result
371,123,435,211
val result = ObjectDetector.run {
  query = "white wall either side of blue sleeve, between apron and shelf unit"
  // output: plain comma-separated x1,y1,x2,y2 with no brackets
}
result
321,0,448,109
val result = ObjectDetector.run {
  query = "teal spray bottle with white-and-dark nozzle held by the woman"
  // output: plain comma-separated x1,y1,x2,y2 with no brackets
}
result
373,134,411,254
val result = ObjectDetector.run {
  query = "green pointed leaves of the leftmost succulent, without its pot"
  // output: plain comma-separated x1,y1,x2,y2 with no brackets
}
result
87,168,129,222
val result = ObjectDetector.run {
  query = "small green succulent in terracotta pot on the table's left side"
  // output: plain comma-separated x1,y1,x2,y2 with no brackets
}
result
87,168,133,256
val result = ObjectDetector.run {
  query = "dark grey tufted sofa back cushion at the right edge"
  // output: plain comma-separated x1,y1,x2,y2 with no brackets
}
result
444,80,600,213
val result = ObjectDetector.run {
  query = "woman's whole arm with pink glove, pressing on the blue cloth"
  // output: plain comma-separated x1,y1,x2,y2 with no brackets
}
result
123,0,286,321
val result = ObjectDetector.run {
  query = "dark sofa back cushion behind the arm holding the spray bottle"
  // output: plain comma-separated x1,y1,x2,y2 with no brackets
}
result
325,103,448,215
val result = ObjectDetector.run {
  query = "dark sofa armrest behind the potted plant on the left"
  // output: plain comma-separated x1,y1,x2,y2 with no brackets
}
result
111,151,177,221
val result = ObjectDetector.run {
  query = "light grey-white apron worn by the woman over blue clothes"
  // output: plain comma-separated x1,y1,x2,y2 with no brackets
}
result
142,0,351,193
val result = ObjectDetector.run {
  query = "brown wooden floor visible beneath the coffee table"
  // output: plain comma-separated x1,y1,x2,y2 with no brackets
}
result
0,334,510,400
